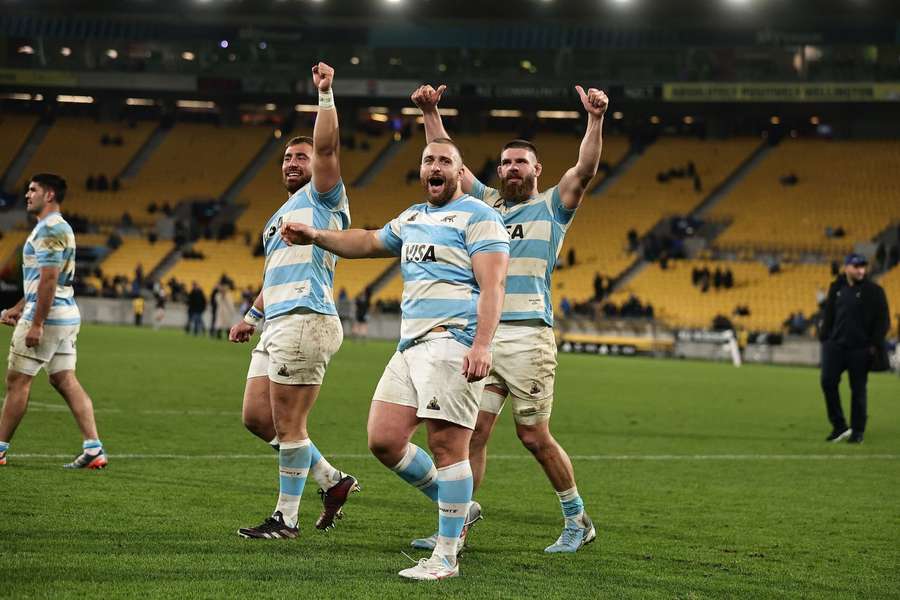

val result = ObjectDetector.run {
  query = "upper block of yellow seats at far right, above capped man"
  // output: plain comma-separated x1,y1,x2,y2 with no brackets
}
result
710,139,900,258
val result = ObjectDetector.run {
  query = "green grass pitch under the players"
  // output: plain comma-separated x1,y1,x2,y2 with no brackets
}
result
0,326,900,599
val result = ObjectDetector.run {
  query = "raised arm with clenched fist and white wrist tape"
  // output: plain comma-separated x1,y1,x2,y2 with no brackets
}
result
312,62,341,194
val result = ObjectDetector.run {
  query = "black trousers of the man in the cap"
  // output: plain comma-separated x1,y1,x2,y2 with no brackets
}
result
821,342,871,433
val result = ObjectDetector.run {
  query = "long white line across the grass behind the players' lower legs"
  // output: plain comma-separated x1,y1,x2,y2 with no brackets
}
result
9,453,900,461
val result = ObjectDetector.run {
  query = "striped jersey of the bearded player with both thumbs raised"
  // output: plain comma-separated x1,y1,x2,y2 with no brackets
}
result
472,179,575,327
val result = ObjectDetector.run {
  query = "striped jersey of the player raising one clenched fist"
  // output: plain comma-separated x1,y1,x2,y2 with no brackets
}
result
262,181,350,319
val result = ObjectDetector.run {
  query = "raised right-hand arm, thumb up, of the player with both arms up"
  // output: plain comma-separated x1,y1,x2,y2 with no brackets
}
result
559,85,609,210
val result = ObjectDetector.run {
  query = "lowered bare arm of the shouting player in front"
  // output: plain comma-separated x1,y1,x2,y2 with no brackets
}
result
463,252,509,381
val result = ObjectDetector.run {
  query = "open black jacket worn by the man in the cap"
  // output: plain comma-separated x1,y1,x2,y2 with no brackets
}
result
819,274,891,371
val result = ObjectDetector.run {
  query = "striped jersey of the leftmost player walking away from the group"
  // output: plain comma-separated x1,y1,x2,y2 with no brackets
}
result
22,212,81,326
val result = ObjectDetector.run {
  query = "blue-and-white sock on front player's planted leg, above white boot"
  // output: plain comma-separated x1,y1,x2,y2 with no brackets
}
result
434,460,473,564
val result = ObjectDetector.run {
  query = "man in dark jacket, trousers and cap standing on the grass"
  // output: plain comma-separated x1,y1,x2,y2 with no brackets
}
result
819,254,890,444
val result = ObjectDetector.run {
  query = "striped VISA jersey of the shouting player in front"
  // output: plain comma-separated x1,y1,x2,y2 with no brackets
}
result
378,195,509,351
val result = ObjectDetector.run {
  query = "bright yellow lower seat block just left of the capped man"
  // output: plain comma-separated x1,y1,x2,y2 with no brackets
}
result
610,260,833,331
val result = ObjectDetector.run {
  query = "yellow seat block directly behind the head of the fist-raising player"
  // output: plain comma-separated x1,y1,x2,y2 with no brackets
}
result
235,130,389,236
